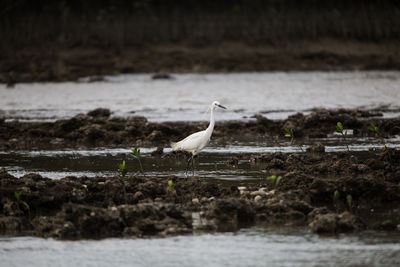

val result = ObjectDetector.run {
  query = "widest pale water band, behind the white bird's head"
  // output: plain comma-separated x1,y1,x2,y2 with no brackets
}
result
0,71,400,122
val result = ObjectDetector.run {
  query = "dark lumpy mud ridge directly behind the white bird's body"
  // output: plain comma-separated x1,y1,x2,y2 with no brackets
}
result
0,108,400,151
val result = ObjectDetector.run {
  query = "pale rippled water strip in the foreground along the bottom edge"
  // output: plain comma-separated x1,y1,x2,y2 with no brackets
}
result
0,227,400,267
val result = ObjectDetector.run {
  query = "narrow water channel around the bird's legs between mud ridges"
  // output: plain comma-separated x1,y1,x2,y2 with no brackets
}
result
0,137,400,181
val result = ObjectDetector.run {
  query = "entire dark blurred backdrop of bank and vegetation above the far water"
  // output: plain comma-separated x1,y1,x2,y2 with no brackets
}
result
0,0,400,84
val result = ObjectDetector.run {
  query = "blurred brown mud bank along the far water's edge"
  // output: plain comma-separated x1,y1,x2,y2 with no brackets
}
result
0,38,400,84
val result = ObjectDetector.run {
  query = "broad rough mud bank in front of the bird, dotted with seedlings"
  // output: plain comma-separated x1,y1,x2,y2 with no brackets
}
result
0,148,400,239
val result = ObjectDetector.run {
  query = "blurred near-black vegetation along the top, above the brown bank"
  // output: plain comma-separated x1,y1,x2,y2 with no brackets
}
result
0,0,400,48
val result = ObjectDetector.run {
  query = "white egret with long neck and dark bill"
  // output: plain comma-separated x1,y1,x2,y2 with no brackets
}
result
171,101,226,176
